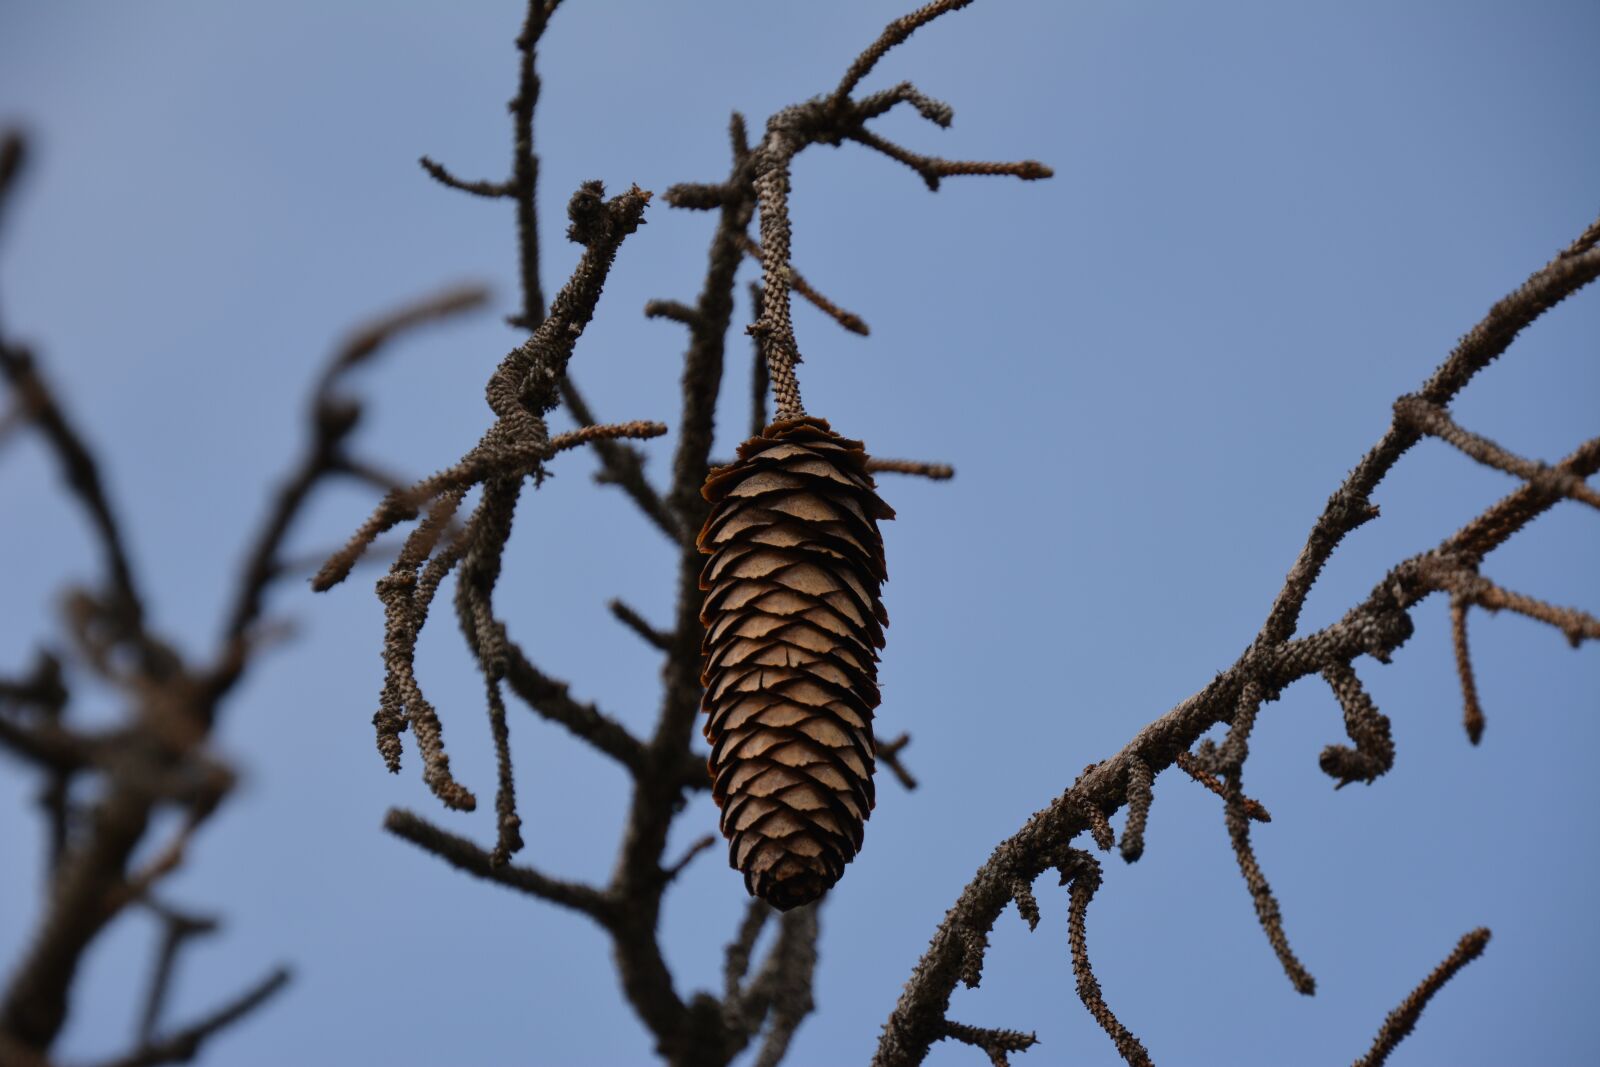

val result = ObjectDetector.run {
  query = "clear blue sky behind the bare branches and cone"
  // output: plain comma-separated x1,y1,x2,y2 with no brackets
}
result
0,0,1600,1065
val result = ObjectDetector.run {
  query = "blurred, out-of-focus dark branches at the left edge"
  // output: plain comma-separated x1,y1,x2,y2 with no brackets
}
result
0,125,467,1067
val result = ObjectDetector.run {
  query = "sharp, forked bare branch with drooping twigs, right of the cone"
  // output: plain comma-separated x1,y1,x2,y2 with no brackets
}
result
874,214,1600,1067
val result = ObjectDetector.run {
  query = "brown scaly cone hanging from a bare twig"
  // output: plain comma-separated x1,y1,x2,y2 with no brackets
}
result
699,418,894,910
